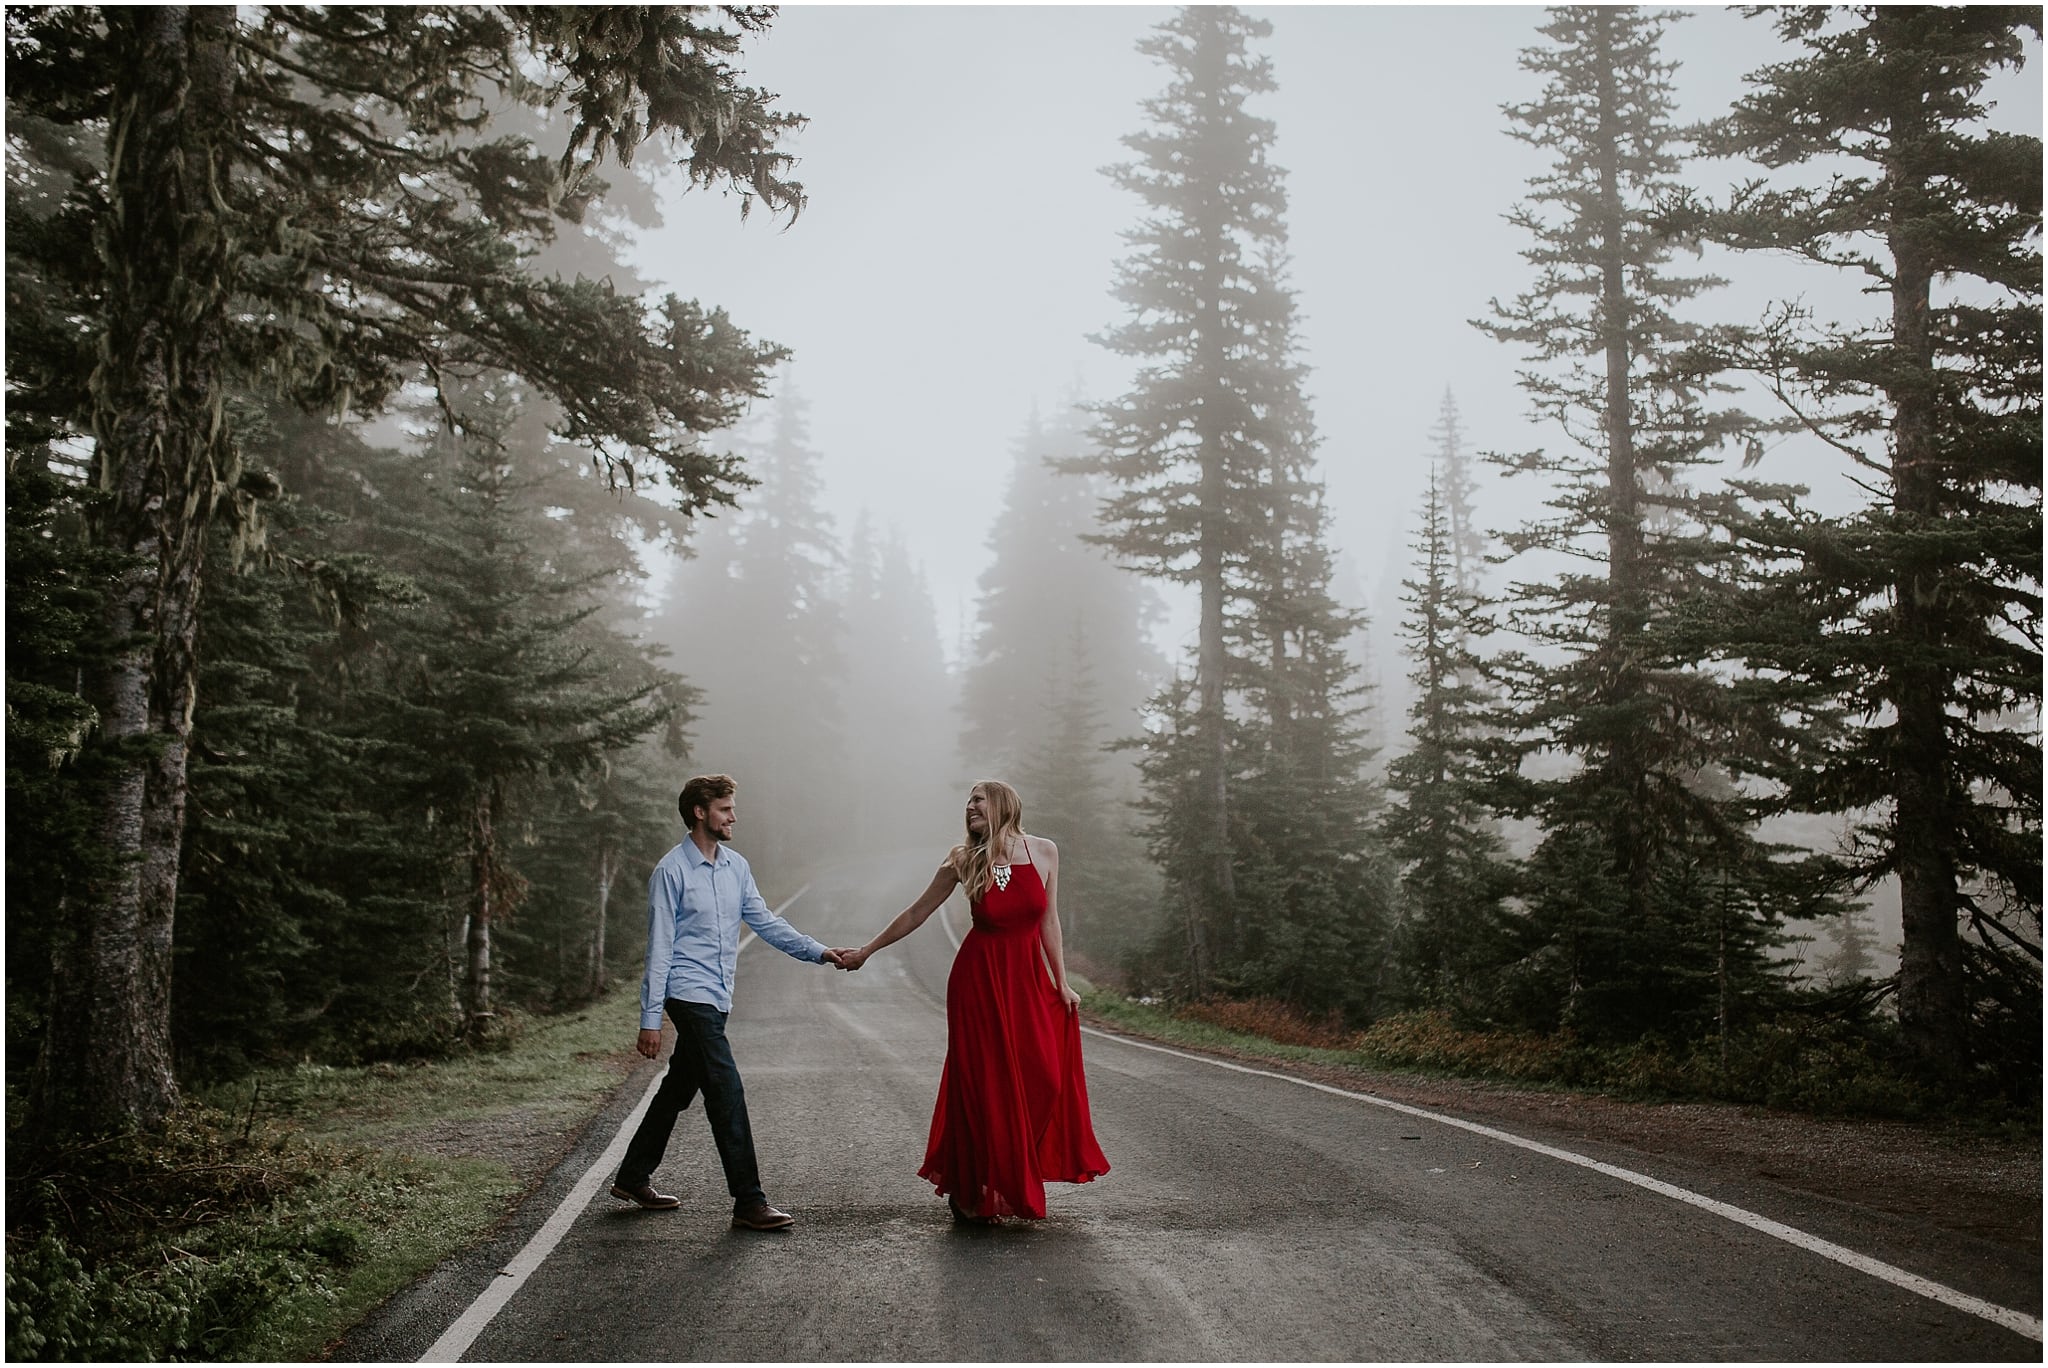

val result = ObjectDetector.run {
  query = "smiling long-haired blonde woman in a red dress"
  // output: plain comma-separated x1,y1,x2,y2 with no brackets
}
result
840,780,1110,1225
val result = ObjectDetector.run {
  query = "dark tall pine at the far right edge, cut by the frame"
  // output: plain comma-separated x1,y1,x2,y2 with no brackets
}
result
1675,6,2042,1085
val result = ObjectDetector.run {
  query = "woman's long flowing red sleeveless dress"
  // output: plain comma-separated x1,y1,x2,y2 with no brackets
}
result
918,860,1110,1221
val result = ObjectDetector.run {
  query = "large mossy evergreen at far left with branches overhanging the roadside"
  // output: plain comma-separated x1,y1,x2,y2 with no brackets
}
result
8,6,801,1132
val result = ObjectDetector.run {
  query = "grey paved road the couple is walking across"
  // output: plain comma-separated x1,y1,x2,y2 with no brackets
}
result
340,852,2042,1362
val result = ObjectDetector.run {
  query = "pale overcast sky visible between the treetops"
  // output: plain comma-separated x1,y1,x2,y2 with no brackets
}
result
635,4,2042,671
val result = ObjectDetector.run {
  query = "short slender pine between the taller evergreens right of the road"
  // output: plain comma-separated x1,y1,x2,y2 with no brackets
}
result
1382,471,1511,1018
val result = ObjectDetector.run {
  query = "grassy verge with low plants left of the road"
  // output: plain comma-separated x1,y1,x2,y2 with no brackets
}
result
6,983,637,1362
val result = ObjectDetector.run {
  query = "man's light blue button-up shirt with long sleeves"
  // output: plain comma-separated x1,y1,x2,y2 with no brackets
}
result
641,838,825,1030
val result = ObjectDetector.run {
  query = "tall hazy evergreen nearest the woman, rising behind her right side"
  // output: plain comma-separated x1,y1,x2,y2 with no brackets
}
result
1081,6,1298,985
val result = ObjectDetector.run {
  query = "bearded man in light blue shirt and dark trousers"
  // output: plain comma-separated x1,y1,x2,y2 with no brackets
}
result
612,774,844,1231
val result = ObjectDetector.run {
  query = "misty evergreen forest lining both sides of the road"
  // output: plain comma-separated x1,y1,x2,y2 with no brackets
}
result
6,6,2042,1351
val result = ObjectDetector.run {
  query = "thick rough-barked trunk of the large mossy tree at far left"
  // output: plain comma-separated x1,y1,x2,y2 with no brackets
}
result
35,6,236,1135
